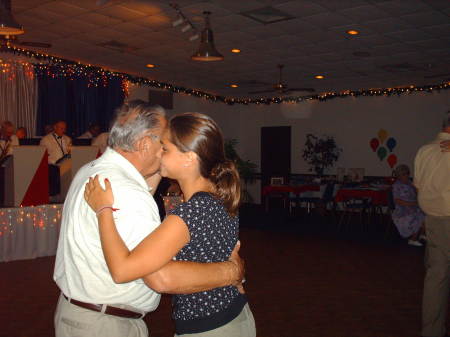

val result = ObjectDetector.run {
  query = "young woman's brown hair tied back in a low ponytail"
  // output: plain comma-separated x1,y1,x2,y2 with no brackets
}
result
169,113,241,216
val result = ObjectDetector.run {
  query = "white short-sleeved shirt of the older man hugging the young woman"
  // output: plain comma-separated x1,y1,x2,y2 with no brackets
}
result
53,148,160,312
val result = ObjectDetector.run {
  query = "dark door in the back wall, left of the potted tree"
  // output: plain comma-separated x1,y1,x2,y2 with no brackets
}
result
261,126,291,186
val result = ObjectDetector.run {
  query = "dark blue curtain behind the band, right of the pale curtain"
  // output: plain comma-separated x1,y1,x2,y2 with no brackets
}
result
36,73,125,138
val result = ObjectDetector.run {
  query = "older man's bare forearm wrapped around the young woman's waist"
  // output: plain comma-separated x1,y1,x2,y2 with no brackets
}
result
143,243,245,294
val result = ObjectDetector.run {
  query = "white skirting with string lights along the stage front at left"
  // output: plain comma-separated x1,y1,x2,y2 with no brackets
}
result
0,205,62,262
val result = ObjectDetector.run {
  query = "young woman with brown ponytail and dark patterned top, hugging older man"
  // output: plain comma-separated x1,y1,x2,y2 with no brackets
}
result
85,113,256,337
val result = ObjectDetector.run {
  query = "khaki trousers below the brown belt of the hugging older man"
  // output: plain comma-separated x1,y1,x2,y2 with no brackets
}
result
55,294,148,337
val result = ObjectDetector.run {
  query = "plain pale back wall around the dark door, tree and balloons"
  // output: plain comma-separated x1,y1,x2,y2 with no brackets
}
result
129,86,450,201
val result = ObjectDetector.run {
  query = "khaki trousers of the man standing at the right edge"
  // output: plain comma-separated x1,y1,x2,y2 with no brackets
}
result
422,215,450,337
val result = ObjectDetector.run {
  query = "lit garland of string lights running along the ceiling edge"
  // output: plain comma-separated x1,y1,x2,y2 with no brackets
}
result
0,46,450,105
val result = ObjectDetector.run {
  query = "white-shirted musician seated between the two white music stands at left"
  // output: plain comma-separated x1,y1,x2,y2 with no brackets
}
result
40,121,72,165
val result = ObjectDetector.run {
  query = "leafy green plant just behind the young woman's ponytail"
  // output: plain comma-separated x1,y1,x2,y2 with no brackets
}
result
224,139,258,202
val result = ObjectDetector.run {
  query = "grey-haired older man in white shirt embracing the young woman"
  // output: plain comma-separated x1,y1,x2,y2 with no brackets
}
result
54,101,242,337
